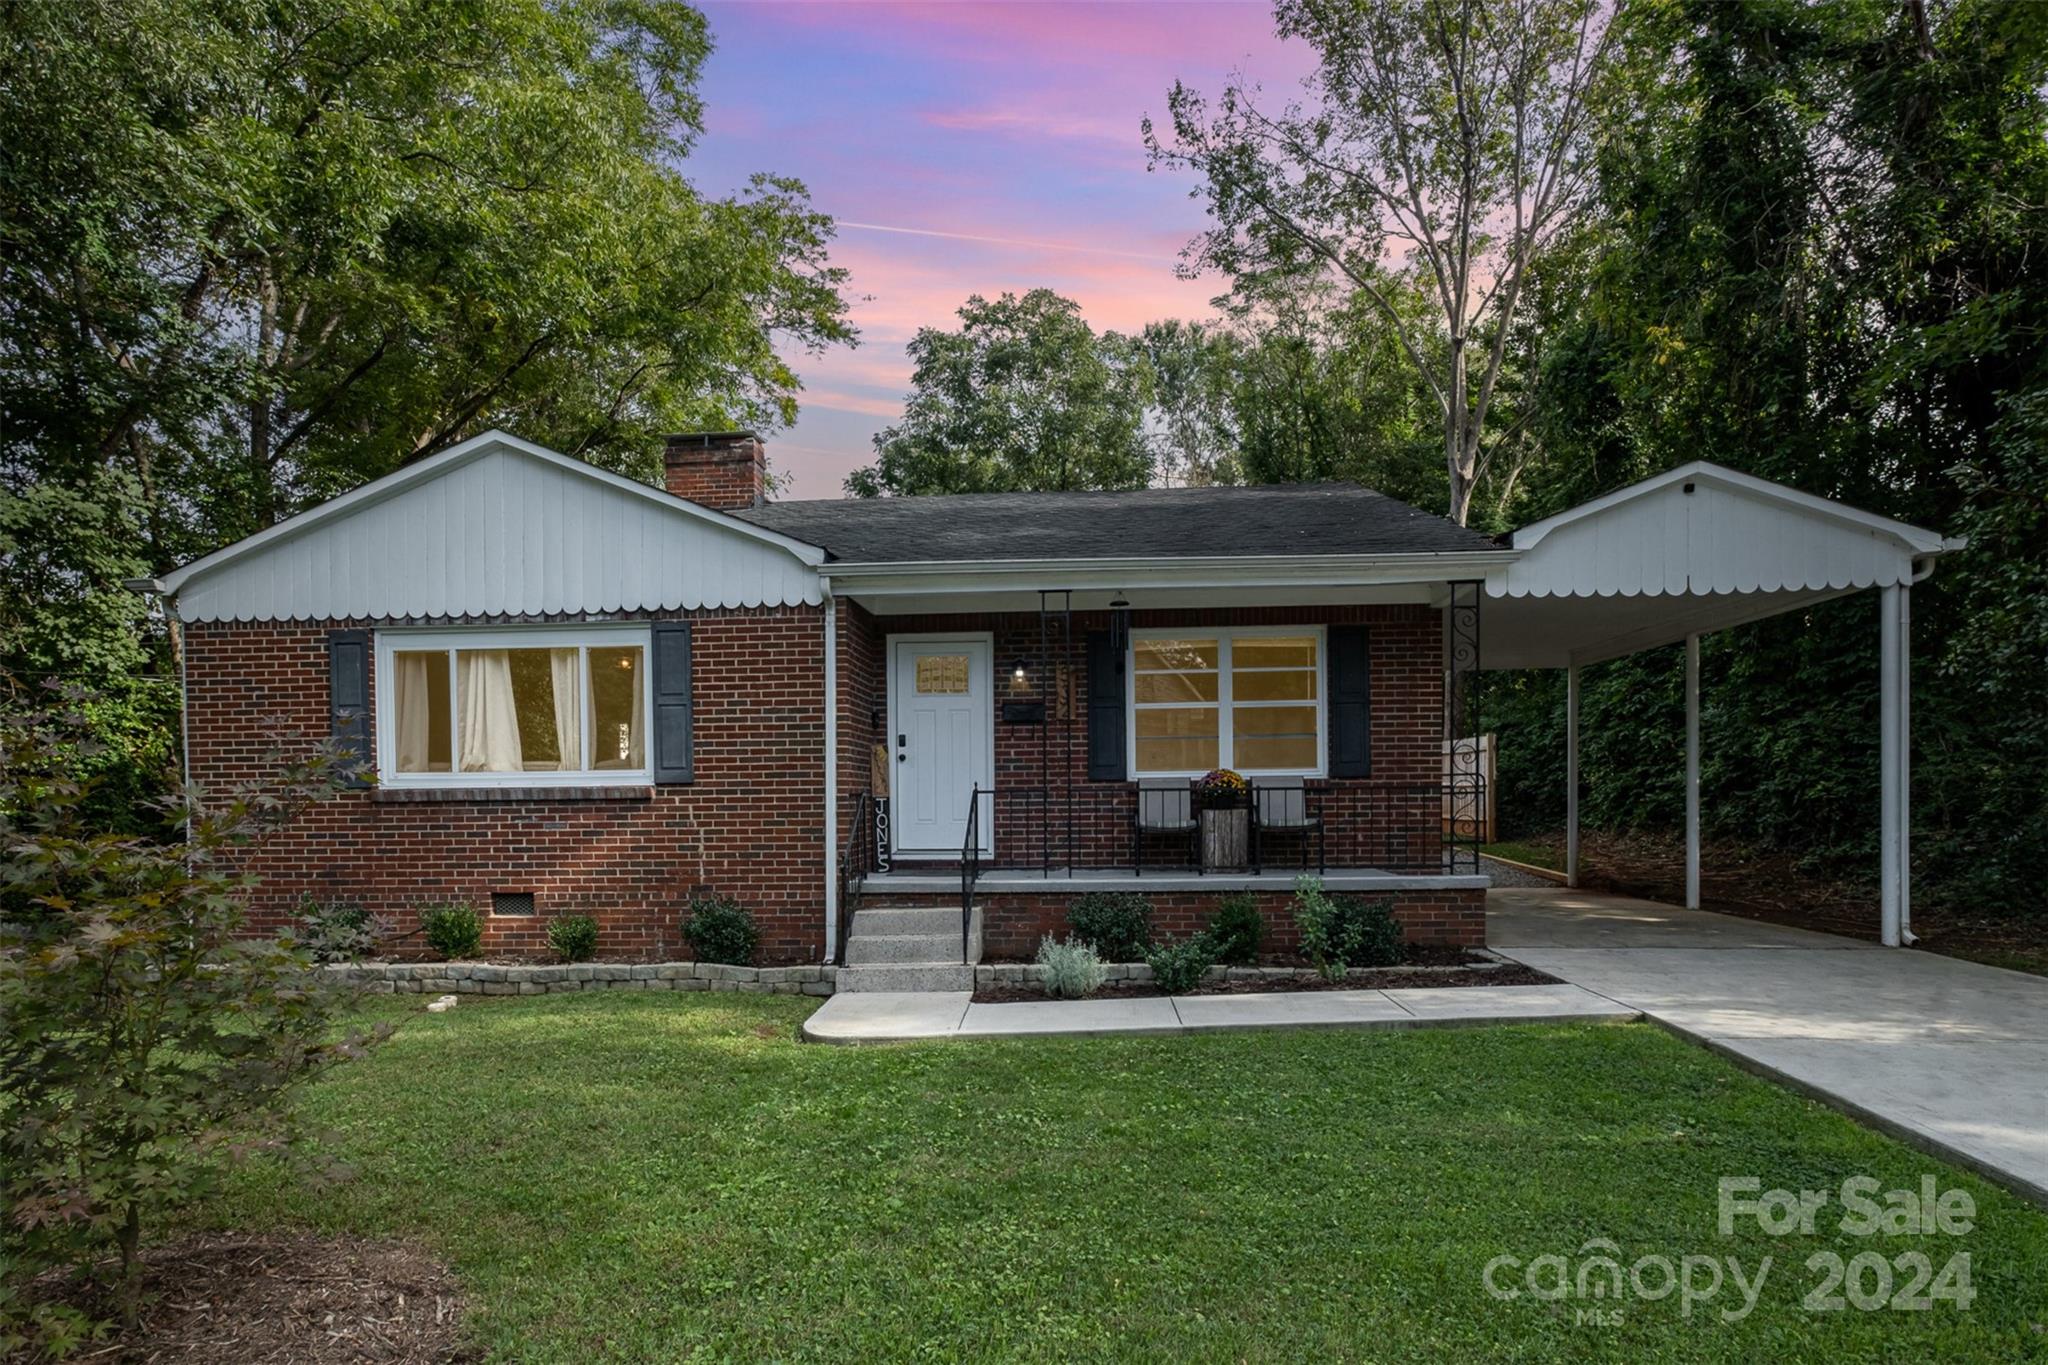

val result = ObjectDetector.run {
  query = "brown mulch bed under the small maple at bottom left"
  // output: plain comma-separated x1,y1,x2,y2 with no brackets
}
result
24,1234,481,1365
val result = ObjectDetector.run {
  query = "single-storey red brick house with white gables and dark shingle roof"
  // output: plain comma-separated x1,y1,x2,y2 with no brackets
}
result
147,432,1944,988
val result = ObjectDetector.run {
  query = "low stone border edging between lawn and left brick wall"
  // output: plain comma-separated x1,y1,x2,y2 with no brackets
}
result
319,962,838,995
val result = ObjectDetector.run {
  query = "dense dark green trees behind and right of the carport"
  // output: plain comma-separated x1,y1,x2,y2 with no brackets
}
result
1493,0,2048,907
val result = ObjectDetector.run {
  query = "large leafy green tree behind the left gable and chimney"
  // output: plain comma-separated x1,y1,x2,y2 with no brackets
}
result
0,0,852,822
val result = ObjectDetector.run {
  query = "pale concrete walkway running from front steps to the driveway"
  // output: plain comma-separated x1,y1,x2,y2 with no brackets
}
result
803,986,1636,1044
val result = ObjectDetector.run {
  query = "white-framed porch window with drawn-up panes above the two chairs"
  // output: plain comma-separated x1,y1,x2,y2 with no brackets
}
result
1126,626,1329,778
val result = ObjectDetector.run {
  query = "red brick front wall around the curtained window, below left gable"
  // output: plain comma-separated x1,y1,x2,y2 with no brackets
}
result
186,608,825,962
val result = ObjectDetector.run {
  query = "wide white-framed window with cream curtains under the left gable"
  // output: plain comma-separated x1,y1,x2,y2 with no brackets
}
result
377,626,651,786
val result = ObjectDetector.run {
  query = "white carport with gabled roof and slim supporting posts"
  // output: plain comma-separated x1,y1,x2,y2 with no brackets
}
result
1479,460,1962,948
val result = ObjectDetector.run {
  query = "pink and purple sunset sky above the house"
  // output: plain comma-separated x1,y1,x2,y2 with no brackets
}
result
688,0,1307,497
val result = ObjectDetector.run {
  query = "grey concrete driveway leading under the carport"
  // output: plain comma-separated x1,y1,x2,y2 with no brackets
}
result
1487,888,2048,1203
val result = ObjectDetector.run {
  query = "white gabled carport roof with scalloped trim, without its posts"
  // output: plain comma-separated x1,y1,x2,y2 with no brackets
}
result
1481,460,1960,669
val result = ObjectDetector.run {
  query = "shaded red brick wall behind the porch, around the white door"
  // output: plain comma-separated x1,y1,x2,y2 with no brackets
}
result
840,604,1444,868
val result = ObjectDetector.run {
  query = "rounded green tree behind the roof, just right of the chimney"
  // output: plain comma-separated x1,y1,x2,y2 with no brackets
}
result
846,289,1153,497
